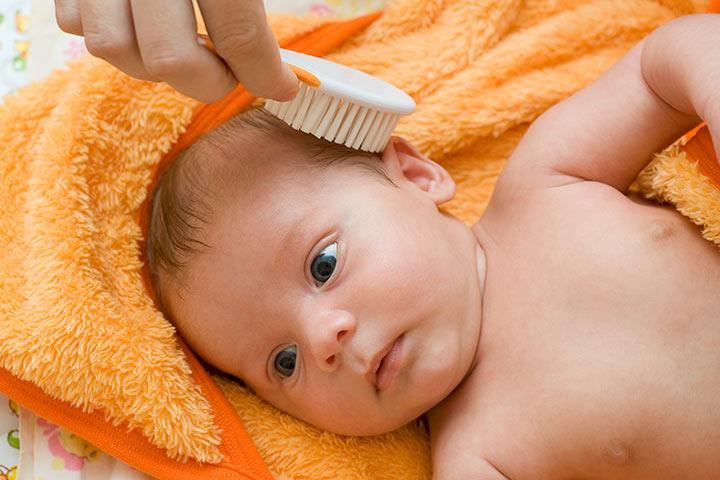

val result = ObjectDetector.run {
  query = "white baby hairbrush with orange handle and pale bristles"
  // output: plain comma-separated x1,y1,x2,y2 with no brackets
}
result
198,34,415,152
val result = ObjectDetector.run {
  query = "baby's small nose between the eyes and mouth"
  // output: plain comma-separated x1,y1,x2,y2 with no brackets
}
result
308,310,357,372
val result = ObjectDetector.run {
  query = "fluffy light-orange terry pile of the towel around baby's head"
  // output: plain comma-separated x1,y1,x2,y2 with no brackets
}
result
0,0,707,479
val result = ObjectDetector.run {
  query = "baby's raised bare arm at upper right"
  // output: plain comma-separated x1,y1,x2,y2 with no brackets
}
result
496,14,720,196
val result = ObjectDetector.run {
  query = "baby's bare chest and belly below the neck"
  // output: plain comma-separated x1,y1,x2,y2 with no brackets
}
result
444,189,720,480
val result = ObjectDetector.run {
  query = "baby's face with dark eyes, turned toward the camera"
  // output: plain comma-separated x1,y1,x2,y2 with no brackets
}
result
165,136,482,435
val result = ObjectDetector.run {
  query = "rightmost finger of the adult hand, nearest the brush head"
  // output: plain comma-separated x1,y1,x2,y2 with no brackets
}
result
199,0,298,100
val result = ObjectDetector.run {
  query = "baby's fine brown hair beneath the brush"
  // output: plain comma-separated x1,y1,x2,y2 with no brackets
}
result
147,108,395,305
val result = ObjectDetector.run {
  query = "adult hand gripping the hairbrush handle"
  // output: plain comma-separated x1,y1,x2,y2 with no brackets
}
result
55,0,298,102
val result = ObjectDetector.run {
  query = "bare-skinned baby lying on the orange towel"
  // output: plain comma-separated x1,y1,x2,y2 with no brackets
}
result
149,15,720,480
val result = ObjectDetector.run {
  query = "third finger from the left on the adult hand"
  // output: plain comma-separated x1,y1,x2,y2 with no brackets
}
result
130,0,237,102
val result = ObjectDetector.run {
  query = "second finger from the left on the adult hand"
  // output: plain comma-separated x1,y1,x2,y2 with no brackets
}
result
80,0,157,80
